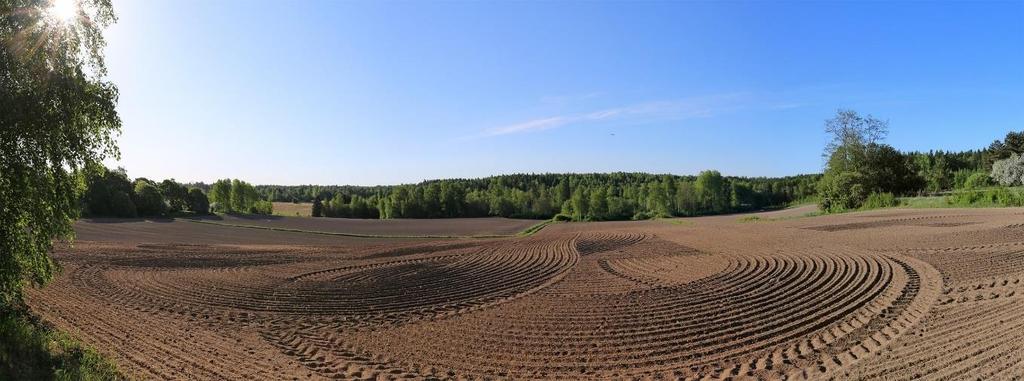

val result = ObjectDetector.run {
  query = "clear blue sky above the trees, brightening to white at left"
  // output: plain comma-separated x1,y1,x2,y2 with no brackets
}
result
106,0,1024,184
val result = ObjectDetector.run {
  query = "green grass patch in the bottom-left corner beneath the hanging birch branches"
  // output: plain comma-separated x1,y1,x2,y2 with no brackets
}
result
0,310,127,380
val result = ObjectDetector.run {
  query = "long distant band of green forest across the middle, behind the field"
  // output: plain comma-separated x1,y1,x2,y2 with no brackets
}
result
282,171,820,221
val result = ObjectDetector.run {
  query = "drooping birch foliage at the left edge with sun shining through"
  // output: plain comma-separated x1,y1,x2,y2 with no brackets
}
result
0,0,121,307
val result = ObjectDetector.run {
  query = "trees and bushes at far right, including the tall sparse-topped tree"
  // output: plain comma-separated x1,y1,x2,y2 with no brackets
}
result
818,110,1024,212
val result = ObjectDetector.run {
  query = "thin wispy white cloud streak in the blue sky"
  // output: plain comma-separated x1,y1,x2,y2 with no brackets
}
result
483,94,744,136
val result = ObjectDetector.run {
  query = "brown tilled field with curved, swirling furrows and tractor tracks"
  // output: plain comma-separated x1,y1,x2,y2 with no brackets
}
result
22,209,1024,380
